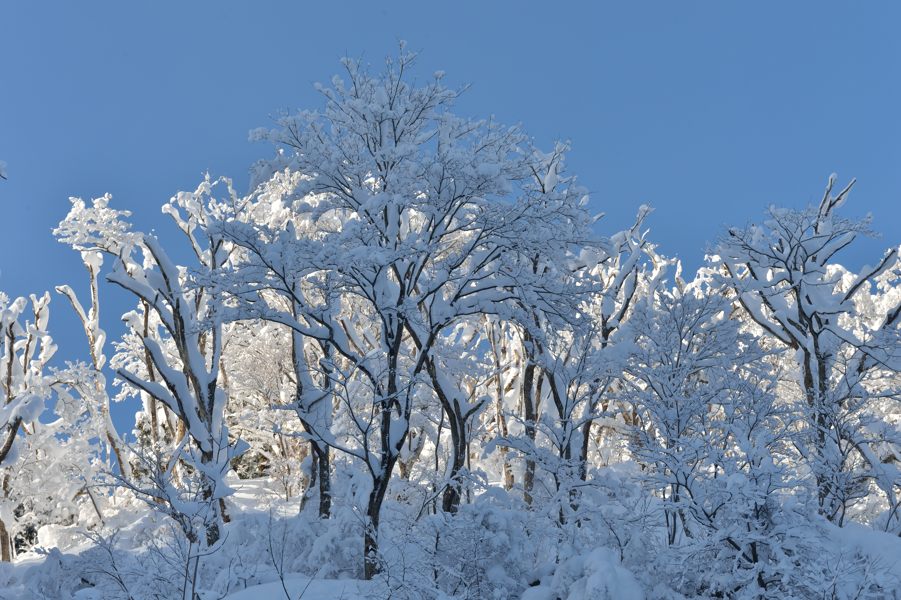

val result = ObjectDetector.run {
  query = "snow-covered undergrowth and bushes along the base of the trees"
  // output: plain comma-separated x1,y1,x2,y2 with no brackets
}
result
0,474,901,600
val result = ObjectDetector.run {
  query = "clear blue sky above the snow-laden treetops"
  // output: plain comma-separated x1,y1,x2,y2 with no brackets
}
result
0,0,901,430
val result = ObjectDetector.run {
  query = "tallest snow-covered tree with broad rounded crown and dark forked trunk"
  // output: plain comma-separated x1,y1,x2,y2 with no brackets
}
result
221,51,591,577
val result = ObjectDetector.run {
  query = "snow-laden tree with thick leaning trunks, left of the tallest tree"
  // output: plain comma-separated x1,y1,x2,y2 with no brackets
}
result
58,178,243,546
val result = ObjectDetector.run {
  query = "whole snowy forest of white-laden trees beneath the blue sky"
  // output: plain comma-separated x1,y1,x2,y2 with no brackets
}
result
0,50,901,600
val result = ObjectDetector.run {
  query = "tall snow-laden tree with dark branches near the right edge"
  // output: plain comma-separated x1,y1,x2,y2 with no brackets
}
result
715,177,901,524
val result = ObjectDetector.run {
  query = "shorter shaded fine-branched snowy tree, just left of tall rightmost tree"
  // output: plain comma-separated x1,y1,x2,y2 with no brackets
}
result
625,277,791,597
